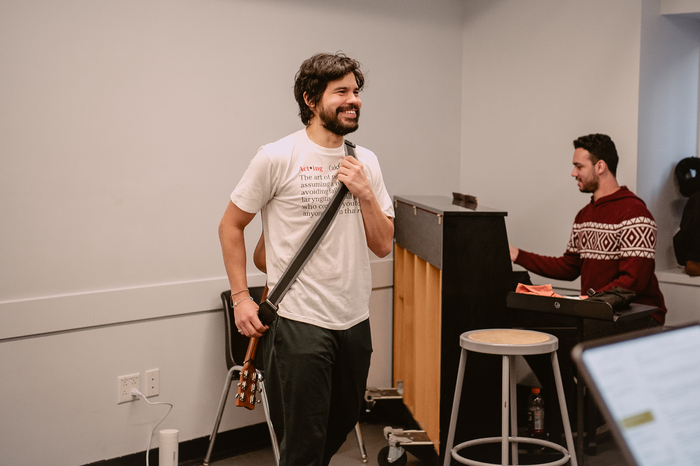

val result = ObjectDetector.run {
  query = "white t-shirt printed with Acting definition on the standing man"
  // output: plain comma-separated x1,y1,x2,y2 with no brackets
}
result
231,129,394,330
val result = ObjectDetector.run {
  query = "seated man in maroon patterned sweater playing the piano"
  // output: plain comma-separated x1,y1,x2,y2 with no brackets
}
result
510,134,666,330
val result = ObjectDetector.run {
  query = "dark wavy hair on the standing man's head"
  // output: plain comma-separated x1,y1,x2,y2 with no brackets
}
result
294,52,365,126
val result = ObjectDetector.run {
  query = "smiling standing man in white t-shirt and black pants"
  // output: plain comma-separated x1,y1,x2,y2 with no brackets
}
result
219,53,394,466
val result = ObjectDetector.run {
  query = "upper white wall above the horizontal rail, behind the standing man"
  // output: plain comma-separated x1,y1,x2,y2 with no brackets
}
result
0,0,461,300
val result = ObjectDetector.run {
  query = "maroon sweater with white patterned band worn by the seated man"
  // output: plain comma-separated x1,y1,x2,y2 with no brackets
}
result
515,186,666,323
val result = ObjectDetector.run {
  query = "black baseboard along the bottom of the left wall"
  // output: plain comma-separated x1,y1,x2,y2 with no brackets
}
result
83,422,271,466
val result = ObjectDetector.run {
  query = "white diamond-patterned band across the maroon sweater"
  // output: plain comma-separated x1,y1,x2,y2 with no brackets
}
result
566,217,657,260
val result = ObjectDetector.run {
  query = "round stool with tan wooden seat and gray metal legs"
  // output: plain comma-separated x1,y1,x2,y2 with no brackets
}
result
444,329,578,466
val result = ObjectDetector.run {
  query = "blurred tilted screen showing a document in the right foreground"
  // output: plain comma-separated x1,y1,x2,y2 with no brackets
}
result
574,325,700,466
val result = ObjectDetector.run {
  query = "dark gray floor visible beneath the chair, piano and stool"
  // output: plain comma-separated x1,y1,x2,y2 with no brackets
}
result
212,424,625,466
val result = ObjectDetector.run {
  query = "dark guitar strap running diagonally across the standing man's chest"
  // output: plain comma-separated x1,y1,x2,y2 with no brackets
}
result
258,139,356,325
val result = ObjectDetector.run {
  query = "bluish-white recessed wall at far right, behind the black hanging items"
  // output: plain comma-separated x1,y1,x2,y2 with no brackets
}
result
638,1,700,270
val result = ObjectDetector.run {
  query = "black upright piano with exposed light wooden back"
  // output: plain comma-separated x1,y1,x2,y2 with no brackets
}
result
393,196,515,458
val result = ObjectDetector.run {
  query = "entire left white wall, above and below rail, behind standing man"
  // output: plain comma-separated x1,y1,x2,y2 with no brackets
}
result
0,0,470,465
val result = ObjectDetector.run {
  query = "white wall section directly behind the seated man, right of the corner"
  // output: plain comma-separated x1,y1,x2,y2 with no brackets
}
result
461,0,641,255
